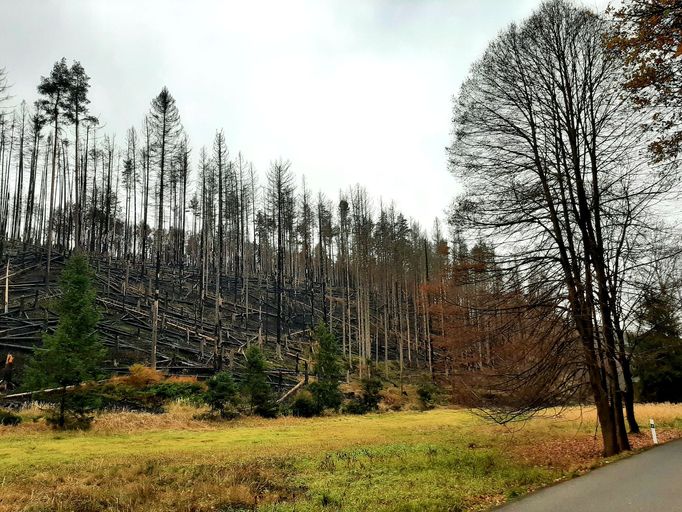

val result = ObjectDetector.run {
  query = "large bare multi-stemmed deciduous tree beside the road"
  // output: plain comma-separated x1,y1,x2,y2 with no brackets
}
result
450,0,676,454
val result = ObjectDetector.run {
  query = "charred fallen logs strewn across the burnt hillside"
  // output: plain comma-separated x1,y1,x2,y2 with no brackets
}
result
0,247,311,390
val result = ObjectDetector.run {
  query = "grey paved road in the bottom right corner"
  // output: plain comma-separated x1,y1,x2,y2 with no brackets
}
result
498,440,682,512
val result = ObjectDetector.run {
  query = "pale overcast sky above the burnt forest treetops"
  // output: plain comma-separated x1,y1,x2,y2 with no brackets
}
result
0,0,607,228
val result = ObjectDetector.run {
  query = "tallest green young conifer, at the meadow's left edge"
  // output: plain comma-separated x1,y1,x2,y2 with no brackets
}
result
24,253,106,428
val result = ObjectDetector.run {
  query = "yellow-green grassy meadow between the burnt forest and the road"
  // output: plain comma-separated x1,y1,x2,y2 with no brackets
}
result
0,404,682,512
